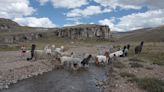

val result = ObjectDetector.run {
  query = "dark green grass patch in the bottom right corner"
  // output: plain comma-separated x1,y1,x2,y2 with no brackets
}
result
129,78,164,92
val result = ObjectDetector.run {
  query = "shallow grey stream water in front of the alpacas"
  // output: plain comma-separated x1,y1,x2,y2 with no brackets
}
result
0,65,108,92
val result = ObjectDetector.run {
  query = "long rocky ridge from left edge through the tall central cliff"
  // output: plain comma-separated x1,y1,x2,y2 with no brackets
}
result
0,24,111,43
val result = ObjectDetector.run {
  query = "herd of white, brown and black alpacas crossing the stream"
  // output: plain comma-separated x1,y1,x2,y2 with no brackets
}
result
22,41,144,70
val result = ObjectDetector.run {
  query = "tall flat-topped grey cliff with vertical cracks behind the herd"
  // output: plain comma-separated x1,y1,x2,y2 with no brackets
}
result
56,24,110,39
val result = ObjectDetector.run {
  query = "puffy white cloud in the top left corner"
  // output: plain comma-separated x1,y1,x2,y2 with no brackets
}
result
0,0,35,19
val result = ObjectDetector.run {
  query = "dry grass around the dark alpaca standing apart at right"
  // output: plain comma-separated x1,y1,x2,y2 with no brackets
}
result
123,42,164,66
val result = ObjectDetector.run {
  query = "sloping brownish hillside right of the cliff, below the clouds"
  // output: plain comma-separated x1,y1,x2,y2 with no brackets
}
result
115,26,164,42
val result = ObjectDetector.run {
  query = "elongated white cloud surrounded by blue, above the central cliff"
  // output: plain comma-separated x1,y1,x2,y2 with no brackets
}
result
66,6,111,17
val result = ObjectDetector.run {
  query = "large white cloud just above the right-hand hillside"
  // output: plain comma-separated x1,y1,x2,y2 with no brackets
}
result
99,9,164,31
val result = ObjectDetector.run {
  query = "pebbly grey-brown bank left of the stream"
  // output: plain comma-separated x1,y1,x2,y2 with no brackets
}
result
0,52,58,89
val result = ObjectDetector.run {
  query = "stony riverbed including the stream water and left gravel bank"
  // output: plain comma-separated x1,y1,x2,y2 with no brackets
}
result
0,47,110,92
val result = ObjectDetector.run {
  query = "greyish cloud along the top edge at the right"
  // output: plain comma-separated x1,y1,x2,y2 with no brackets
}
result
94,0,164,9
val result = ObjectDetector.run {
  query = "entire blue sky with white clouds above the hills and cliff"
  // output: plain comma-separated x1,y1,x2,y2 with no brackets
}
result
0,0,164,32
